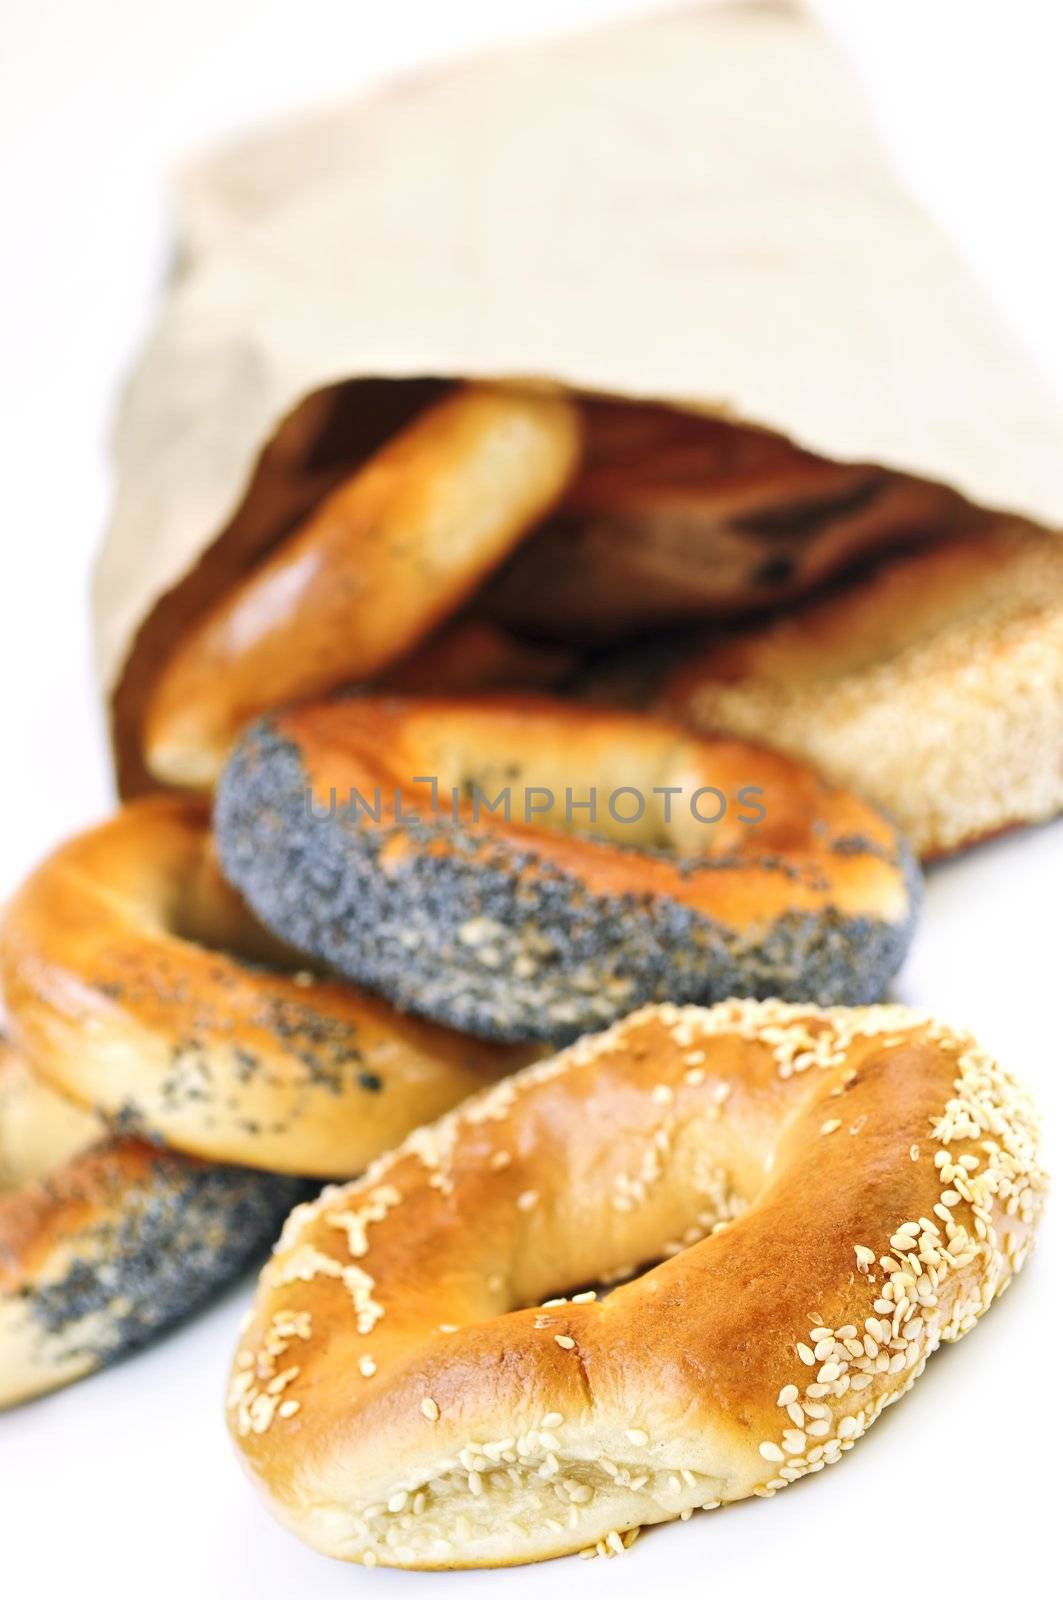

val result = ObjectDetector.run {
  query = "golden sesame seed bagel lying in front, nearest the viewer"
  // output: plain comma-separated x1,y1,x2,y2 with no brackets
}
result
229,1000,1044,1568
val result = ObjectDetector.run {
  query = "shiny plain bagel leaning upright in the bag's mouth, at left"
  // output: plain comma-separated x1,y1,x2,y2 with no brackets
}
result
142,384,580,789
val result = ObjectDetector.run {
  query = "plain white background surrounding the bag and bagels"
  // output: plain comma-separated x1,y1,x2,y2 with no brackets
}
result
0,0,1063,1600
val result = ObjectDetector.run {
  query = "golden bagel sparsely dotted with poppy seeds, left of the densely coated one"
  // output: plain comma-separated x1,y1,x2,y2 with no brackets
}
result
0,797,528,1178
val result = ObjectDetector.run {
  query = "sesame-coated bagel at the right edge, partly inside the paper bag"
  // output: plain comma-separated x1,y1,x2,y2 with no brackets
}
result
661,523,1063,859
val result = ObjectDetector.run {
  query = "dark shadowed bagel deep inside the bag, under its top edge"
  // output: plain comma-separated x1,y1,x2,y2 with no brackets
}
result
475,400,975,643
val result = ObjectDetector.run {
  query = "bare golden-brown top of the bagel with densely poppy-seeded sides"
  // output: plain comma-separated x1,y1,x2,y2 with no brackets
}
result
281,696,903,926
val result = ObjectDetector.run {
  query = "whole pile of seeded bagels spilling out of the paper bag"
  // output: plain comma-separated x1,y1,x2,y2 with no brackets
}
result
0,384,1063,1568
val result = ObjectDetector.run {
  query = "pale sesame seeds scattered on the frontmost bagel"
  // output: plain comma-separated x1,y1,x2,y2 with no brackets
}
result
232,1002,1041,1565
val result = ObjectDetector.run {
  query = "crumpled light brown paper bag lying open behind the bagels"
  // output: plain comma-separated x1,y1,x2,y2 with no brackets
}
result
94,3,1063,792
